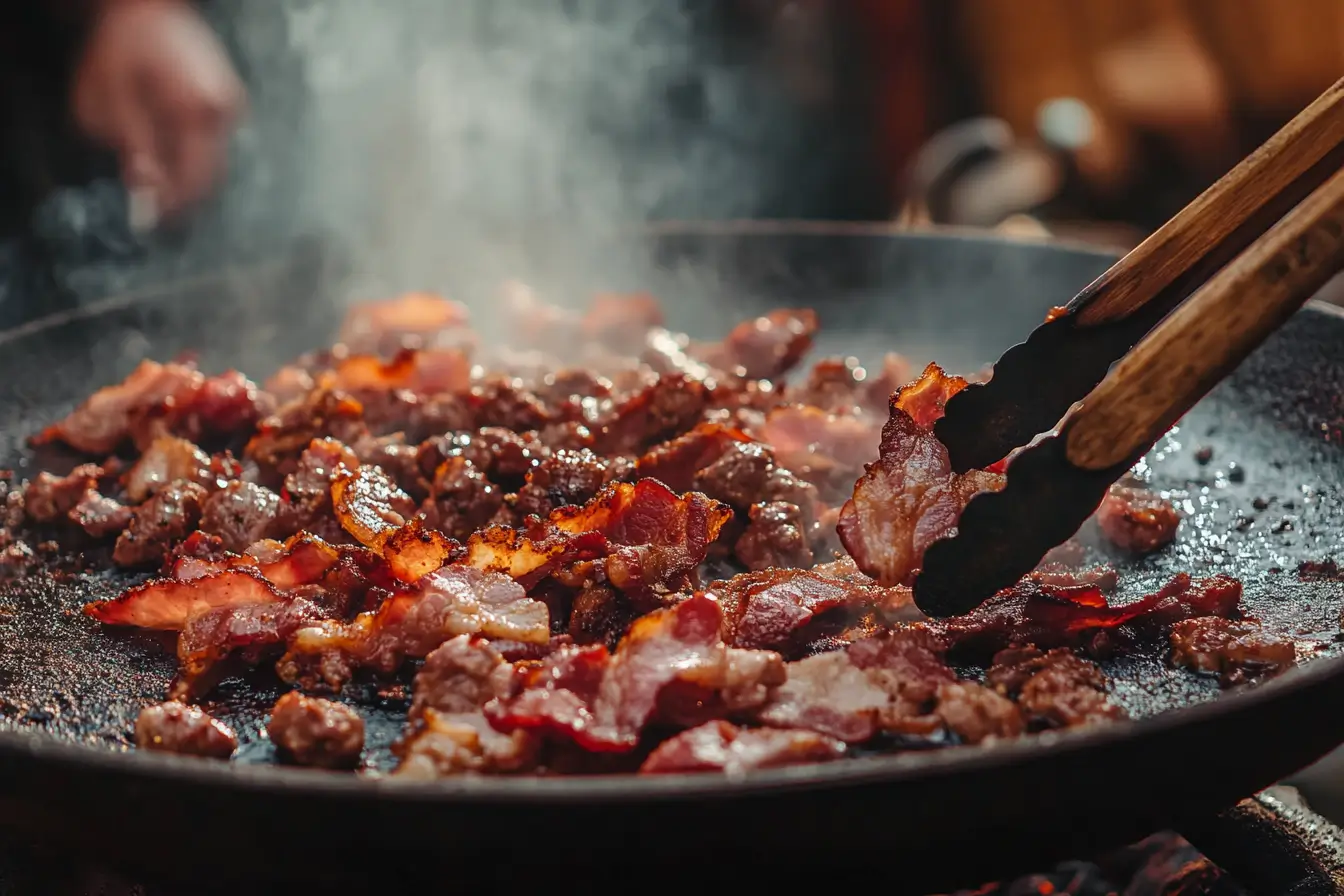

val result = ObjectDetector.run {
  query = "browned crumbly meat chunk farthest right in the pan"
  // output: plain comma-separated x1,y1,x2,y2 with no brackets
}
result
1171,617,1297,688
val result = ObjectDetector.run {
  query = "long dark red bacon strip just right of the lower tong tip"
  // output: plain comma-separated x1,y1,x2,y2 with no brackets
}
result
931,572,1242,654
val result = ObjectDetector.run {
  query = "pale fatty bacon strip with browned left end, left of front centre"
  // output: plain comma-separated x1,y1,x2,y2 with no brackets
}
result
277,566,551,690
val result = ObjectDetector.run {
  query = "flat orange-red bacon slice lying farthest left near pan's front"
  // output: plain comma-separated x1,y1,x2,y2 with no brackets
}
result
85,567,285,631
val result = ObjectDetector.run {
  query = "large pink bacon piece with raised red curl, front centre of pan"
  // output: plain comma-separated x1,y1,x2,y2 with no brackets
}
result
485,595,784,752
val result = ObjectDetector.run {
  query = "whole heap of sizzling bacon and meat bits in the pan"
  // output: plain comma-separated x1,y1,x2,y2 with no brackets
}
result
4,292,1296,778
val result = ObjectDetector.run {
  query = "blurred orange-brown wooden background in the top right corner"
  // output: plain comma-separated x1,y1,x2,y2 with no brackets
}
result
958,0,1344,174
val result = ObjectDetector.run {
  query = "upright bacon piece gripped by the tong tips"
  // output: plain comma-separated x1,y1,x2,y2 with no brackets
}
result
837,364,1004,584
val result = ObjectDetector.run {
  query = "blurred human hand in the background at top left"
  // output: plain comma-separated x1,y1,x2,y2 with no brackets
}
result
71,0,246,228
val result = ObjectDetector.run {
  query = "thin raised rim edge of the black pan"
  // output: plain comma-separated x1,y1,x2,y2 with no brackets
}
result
0,231,1344,806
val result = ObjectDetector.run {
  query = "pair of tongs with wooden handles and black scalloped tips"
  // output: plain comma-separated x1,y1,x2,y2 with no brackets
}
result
914,79,1344,617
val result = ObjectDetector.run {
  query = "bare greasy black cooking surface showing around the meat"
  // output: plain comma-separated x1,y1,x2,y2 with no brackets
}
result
0,291,1344,768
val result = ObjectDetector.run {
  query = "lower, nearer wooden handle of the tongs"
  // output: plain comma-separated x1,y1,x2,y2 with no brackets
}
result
1060,171,1344,470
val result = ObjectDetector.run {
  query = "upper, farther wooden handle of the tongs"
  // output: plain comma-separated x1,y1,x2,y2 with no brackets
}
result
1070,79,1344,326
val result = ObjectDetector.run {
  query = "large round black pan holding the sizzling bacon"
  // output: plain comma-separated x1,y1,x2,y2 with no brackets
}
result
0,226,1344,892
